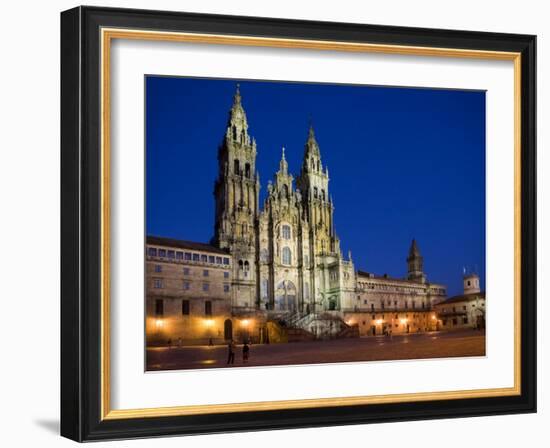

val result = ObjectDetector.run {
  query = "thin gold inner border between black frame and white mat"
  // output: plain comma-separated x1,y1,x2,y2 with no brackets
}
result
100,28,521,420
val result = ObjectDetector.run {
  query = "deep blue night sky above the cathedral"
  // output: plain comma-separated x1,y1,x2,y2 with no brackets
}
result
146,76,485,296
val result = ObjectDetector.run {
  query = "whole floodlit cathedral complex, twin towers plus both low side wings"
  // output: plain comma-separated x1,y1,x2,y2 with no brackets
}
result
146,86,452,344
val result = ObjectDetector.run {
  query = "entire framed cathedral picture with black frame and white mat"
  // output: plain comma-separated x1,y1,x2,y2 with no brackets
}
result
61,7,536,441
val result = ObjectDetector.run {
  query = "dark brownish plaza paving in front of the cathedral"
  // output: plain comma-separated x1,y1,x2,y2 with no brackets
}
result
147,330,485,370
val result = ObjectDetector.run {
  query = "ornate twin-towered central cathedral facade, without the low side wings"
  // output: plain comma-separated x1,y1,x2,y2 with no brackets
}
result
212,87,355,314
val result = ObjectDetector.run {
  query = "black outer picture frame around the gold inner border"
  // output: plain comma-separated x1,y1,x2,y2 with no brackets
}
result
61,7,537,441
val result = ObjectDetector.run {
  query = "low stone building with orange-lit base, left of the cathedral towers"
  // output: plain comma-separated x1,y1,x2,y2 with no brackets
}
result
145,236,233,345
